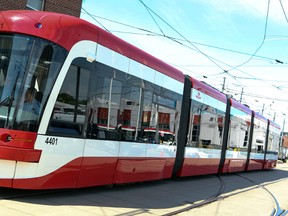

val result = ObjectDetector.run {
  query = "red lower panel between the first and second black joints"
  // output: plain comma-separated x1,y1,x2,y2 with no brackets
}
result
177,158,220,176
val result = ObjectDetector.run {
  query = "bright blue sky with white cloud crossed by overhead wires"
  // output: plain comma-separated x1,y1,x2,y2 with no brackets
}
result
81,0,288,131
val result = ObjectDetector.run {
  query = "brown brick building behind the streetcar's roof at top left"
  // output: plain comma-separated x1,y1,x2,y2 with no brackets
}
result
0,0,82,17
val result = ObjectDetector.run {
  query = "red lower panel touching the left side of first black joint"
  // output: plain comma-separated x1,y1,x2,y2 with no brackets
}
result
114,158,174,184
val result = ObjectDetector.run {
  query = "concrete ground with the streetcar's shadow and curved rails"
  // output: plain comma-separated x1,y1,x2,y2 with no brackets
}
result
0,164,288,216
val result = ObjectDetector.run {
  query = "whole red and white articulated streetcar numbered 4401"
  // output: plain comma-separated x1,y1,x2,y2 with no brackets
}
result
0,11,280,189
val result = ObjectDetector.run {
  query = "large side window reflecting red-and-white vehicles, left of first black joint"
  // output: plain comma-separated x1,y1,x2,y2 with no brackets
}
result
87,63,181,144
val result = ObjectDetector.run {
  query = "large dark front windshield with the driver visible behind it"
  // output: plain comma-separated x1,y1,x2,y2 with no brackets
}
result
0,34,67,131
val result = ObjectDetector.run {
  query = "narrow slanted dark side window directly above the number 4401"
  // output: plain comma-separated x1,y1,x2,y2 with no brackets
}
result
48,59,90,136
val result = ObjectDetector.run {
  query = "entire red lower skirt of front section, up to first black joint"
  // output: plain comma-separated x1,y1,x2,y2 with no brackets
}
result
9,157,174,189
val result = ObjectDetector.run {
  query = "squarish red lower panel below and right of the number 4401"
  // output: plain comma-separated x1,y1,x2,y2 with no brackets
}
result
78,157,117,187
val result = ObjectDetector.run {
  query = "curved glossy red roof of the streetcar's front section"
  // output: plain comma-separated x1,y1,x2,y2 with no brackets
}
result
0,10,184,82
